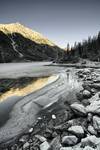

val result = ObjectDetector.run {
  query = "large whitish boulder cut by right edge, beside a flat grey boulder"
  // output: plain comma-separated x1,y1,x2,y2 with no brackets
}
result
86,101,100,115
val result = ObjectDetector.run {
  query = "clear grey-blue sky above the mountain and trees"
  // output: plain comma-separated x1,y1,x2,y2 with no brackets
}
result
0,0,100,47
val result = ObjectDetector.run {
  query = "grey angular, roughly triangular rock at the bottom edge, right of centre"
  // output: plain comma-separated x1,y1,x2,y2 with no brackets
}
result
49,137,61,150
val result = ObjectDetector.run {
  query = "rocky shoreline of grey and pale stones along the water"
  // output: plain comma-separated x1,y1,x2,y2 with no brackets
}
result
1,69,100,150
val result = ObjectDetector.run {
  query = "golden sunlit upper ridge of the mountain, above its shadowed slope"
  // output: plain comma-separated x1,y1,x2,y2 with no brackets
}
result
0,22,55,46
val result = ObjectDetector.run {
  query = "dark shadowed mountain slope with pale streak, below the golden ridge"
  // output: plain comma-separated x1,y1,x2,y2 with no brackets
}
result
0,31,64,63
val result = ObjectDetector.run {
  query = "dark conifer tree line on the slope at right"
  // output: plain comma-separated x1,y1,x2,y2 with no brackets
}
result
64,32,100,62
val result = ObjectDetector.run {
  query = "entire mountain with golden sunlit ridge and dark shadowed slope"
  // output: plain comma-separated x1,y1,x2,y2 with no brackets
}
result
0,23,63,63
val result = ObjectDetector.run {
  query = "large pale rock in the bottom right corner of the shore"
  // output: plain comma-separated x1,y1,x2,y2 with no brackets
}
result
81,135,100,148
